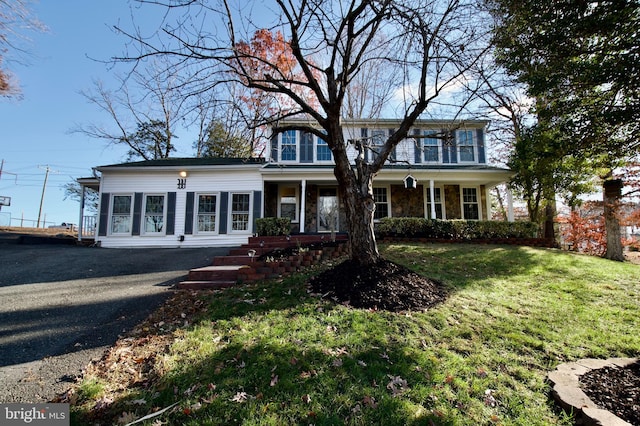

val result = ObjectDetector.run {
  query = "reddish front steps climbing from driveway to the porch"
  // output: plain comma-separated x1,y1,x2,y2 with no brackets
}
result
177,235,346,290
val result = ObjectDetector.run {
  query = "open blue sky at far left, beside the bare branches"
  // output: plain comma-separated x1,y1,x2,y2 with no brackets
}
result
0,0,191,226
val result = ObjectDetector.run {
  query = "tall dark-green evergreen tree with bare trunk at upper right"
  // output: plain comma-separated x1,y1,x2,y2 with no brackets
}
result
487,0,640,260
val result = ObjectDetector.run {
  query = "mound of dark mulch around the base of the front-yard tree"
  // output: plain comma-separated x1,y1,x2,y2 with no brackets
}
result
309,259,447,312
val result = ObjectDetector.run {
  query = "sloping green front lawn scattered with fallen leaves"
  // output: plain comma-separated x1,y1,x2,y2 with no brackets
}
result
72,244,640,426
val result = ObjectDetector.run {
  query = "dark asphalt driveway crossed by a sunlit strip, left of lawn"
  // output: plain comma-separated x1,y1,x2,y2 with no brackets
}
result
0,244,229,403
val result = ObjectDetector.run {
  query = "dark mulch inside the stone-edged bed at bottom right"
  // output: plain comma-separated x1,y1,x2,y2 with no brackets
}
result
580,362,640,426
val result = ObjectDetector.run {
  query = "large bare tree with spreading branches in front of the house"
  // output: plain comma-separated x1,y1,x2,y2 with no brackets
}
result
121,0,487,265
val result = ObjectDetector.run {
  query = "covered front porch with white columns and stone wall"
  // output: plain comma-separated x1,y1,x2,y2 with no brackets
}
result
263,167,513,233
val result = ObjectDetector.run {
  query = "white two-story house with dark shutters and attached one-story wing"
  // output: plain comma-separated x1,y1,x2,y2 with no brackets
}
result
79,120,512,247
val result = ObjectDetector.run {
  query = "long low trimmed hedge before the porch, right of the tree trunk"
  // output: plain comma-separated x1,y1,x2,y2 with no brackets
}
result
376,217,538,240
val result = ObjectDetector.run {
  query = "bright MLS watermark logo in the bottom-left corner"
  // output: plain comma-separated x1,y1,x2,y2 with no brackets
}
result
0,404,69,426
